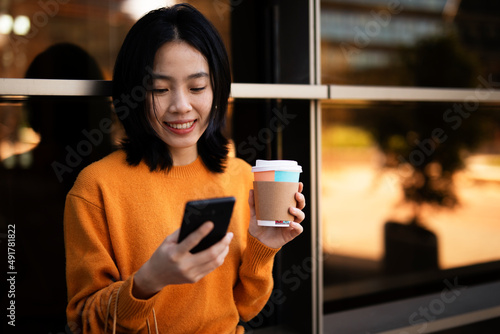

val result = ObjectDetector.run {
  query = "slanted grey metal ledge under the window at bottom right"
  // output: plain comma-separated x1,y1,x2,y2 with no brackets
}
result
323,281,500,334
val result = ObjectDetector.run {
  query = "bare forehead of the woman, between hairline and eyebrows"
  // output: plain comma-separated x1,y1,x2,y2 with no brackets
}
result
153,41,209,79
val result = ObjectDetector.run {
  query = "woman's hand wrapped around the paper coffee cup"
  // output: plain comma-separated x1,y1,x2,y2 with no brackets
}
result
248,182,306,248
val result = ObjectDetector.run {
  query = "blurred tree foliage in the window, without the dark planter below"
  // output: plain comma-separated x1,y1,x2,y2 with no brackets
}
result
369,35,487,215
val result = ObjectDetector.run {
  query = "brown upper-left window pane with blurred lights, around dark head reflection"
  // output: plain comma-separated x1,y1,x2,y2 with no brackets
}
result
0,0,233,80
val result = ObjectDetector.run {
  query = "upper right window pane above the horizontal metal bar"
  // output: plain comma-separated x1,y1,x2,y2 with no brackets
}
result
320,0,500,87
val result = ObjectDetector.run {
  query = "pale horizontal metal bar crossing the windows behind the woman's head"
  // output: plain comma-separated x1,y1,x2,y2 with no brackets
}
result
0,79,500,103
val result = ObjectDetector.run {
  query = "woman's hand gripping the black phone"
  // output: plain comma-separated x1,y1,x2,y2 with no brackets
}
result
132,222,233,299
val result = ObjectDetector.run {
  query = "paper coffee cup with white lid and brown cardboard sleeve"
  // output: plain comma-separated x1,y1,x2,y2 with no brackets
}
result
252,160,302,227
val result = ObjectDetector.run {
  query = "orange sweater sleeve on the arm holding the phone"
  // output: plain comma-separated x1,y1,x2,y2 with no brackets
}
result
64,193,156,333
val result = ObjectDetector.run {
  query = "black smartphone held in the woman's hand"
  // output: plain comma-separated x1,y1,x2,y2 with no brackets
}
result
178,197,236,254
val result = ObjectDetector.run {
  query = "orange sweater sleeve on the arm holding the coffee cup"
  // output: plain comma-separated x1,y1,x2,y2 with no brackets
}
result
234,233,279,321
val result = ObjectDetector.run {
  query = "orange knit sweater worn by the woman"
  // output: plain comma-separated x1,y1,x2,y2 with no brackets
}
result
64,151,278,334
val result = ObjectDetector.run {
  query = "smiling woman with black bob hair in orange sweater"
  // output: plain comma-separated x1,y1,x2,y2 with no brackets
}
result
65,4,305,333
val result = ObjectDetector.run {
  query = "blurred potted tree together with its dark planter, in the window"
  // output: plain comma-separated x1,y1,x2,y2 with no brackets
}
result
354,35,498,273
